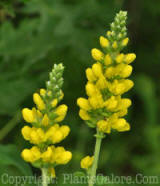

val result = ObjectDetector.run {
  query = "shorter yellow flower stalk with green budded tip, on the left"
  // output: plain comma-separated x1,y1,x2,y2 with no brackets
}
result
21,64,72,186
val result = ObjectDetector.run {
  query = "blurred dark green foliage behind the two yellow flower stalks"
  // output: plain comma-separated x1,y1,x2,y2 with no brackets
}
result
0,0,160,186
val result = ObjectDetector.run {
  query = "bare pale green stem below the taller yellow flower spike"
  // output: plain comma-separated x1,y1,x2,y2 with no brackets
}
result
88,130,104,186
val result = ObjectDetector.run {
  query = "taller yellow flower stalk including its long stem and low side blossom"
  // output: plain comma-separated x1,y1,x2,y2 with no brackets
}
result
77,11,136,186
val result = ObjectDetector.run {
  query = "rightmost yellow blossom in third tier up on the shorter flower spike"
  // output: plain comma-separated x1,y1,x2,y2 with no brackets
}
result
55,104,68,122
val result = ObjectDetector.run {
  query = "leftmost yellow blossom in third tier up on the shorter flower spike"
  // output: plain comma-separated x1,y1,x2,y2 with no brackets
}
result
22,108,36,123
